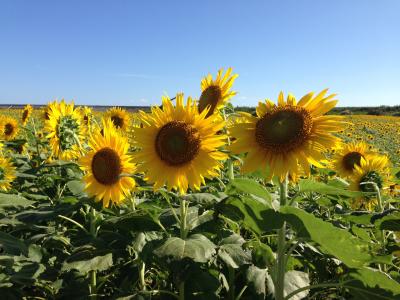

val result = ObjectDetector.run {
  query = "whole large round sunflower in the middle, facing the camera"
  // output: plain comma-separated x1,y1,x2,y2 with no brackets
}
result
133,94,227,194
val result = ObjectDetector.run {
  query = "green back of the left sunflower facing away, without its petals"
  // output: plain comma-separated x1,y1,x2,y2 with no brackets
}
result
57,116,79,151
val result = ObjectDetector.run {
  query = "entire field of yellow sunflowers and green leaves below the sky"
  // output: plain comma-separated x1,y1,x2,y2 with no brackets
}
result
0,68,400,300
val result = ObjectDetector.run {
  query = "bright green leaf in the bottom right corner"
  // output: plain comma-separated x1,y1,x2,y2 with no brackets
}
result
346,268,400,299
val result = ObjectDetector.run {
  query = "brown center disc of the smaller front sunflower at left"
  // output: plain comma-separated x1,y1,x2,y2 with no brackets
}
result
92,148,121,185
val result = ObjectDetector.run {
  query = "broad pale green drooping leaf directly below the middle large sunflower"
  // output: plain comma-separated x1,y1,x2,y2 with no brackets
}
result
154,234,215,263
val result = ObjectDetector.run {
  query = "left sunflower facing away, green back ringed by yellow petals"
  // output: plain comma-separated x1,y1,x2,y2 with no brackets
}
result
45,100,85,160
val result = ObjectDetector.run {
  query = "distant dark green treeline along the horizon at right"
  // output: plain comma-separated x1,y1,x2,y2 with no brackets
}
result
235,105,400,117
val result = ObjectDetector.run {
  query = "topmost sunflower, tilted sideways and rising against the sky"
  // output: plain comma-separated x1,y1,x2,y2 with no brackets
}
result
199,68,239,117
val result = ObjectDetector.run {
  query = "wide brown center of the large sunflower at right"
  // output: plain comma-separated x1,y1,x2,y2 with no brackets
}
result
256,105,313,153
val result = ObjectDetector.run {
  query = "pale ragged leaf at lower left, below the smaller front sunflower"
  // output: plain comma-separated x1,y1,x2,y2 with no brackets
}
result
62,253,113,274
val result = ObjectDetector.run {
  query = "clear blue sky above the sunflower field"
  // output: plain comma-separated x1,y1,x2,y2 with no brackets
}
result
0,0,400,106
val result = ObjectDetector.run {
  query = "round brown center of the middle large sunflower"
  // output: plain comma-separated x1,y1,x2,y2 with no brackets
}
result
155,121,200,166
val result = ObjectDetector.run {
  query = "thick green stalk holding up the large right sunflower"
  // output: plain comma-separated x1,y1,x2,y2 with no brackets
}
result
275,178,287,300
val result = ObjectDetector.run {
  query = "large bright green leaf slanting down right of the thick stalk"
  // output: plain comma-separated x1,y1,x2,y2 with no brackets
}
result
281,206,372,268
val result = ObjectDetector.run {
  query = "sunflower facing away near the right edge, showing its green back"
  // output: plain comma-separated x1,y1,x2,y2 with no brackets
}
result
349,155,390,211
